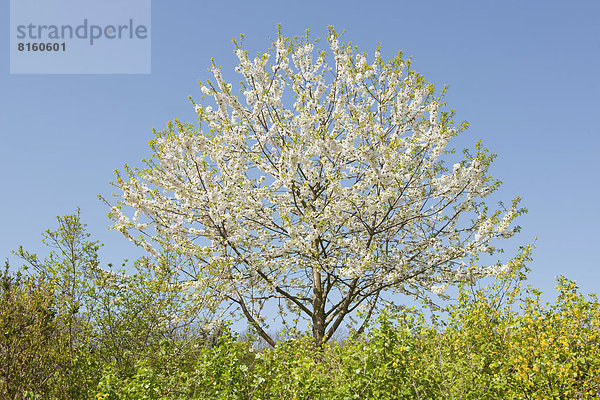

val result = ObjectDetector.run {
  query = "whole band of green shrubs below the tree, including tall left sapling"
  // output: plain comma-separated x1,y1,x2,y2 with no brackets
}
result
0,214,600,400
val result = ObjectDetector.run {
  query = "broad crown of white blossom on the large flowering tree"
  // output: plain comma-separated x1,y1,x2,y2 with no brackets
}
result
110,31,521,346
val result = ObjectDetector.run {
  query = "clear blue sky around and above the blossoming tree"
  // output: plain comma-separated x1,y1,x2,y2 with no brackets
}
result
0,0,600,306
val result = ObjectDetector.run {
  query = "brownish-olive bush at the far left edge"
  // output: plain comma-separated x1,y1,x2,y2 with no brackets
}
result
0,266,95,399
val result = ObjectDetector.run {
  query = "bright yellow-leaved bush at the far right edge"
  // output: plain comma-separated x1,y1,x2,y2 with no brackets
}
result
508,276,600,399
